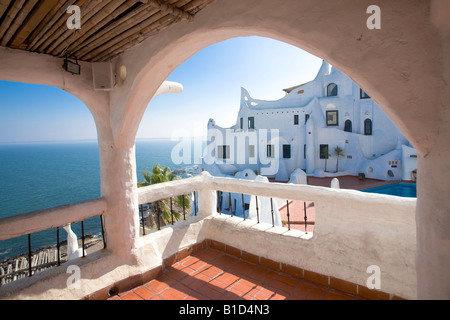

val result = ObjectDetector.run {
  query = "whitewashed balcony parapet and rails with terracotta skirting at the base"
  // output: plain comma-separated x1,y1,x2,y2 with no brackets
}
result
0,173,417,299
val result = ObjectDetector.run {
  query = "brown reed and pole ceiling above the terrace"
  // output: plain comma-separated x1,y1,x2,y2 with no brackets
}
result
0,0,214,62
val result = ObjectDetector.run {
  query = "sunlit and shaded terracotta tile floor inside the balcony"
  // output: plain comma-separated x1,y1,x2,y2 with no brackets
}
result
109,248,358,300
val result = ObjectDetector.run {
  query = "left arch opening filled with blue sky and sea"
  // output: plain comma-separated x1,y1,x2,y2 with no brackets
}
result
0,81,101,261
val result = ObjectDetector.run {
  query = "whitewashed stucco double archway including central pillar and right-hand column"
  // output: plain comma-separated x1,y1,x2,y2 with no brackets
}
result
0,0,450,298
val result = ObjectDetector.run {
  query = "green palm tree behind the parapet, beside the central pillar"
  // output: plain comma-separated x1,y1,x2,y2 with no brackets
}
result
138,164,191,226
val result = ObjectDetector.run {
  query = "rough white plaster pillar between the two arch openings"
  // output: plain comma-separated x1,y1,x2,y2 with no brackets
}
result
97,77,183,261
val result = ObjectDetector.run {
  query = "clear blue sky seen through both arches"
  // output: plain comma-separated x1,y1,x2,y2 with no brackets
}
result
0,37,322,143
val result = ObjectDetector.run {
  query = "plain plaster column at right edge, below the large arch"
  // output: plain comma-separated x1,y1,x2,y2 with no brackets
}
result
416,141,450,299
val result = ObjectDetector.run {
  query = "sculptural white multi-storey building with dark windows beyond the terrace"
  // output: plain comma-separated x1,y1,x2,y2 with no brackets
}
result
202,61,417,181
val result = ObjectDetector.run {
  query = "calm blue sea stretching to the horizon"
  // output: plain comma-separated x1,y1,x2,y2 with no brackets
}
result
0,139,204,261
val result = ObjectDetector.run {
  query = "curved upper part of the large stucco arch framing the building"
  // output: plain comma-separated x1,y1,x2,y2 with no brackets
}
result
112,0,440,155
